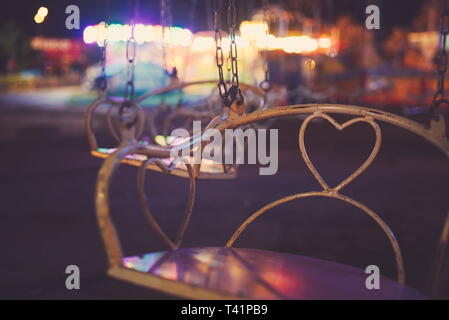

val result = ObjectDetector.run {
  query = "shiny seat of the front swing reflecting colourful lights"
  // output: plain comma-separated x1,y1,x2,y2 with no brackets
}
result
109,247,425,300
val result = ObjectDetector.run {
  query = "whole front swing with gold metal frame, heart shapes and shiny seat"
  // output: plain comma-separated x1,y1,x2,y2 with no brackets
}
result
88,0,449,299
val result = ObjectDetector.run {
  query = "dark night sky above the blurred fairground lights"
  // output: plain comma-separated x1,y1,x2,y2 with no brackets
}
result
4,0,430,37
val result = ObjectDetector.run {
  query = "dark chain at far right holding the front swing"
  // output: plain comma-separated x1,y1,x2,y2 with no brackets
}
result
430,0,449,116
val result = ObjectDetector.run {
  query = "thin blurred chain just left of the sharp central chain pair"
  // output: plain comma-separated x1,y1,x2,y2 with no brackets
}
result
161,0,178,78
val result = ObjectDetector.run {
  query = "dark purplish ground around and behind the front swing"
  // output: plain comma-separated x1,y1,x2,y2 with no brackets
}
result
0,106,449,299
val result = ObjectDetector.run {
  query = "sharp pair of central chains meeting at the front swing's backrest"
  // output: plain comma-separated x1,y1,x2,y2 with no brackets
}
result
214,0,244,108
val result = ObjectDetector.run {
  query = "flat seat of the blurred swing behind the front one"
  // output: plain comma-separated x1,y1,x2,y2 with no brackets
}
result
91,148,237,180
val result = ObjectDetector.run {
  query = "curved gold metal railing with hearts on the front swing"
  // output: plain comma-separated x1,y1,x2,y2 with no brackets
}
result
96,104,449,296
